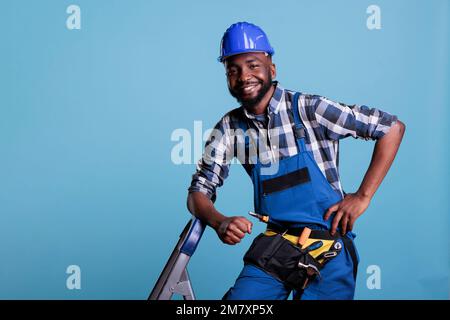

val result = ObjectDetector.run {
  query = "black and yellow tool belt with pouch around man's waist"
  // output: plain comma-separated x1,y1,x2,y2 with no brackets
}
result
244,224,344,290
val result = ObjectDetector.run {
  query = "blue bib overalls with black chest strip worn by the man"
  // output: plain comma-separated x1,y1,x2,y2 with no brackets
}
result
223,92,358,300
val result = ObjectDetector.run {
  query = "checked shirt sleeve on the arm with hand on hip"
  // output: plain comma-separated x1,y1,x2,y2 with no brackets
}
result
314,97,397,140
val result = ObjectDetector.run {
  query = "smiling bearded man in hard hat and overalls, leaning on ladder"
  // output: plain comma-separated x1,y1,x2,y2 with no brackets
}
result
188,22,405,300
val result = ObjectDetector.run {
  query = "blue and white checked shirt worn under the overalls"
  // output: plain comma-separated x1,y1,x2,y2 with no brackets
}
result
189,82,397,201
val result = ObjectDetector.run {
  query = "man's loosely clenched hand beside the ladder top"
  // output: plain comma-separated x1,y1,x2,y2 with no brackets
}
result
216,217,253,245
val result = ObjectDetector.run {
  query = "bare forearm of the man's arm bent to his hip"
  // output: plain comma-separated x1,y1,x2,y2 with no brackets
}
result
357,121,405,199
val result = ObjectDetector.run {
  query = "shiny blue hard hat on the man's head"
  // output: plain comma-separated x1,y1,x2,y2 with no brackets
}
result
217,22,275,62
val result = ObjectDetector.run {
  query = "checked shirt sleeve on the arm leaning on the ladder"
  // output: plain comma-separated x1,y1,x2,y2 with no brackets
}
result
188,115,233,201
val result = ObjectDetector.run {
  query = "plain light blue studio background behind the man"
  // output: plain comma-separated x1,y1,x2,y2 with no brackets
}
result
0,0,450,299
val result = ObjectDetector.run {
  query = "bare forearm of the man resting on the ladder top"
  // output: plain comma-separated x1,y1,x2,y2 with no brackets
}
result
187,192,226,229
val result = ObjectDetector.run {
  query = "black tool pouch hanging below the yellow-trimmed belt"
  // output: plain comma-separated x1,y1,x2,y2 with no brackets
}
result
244,233,336,290
